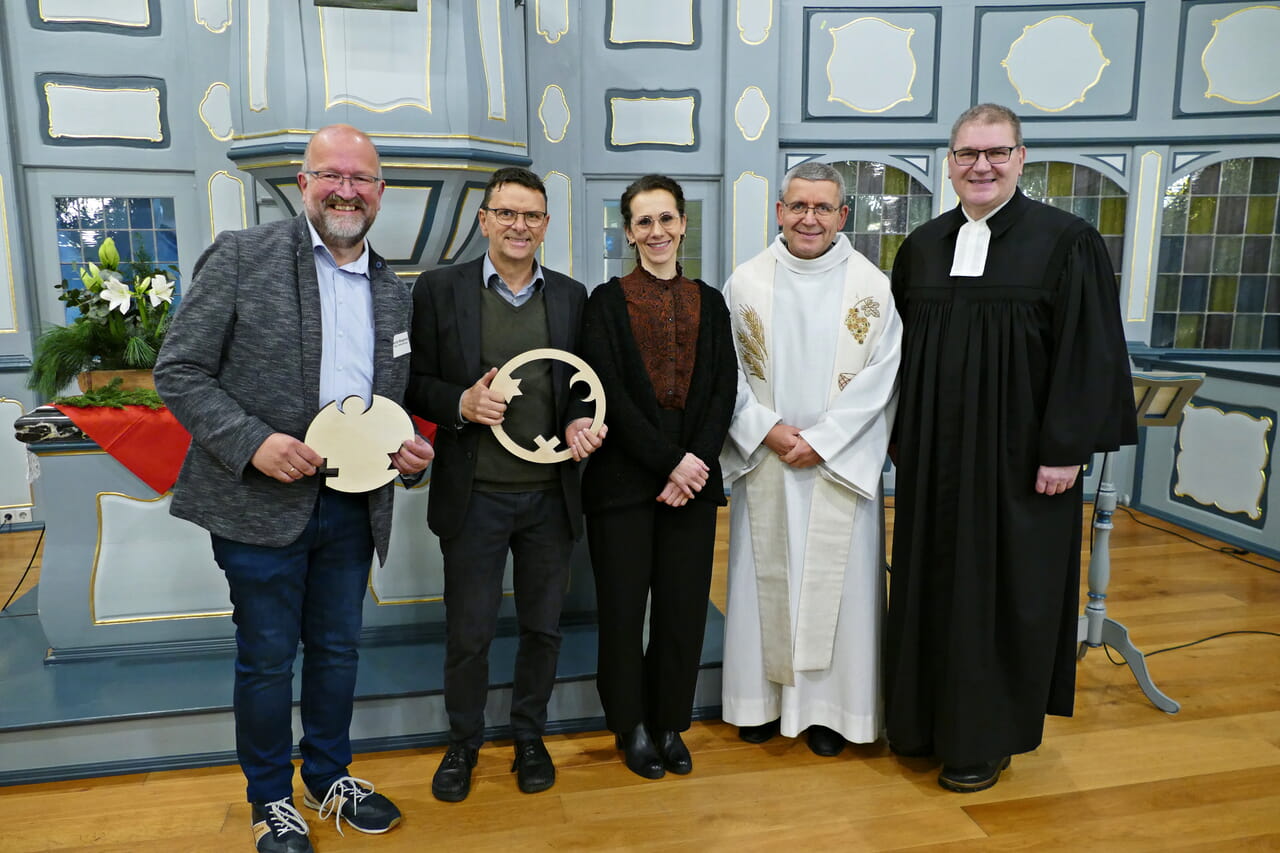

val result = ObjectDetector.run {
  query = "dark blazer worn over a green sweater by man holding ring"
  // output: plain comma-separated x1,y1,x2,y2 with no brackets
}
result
407,257,586,538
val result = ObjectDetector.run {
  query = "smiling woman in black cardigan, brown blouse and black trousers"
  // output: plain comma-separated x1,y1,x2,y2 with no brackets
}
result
582,174,737,779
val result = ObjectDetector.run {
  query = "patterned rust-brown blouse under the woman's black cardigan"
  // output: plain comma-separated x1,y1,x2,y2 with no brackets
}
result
622,265,701,410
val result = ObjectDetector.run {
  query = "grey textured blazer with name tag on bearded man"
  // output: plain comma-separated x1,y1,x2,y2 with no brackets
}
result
155,215,411,560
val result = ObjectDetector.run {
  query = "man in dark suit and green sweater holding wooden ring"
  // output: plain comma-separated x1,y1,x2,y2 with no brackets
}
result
407,168,604,802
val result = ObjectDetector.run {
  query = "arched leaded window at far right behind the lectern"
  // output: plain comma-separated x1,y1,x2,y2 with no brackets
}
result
1151,158,1280,350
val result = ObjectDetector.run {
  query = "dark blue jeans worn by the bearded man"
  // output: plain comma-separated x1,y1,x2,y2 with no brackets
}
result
212,488,374,802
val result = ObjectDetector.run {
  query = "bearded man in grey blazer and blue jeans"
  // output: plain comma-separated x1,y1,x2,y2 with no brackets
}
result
155,126,434,853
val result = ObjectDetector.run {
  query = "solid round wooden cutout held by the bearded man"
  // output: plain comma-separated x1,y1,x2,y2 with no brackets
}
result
302,394,413,492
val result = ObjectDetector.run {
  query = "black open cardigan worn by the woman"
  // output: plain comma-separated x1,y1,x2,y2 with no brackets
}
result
582,278,737,512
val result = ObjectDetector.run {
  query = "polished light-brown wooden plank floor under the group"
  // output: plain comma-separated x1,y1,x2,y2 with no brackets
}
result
0,511,1280,853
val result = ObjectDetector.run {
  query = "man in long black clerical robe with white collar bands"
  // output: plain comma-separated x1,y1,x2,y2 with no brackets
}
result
884,104,1137,792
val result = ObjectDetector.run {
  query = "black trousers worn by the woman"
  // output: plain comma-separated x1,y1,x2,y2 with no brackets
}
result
586,501,717,734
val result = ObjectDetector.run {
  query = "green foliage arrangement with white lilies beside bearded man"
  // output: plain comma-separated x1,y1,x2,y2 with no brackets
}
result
27,237,177,400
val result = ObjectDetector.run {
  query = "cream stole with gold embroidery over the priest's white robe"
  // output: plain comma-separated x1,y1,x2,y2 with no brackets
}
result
730,250,887,685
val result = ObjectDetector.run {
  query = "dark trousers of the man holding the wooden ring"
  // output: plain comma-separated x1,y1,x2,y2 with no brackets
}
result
440,489,573,748
